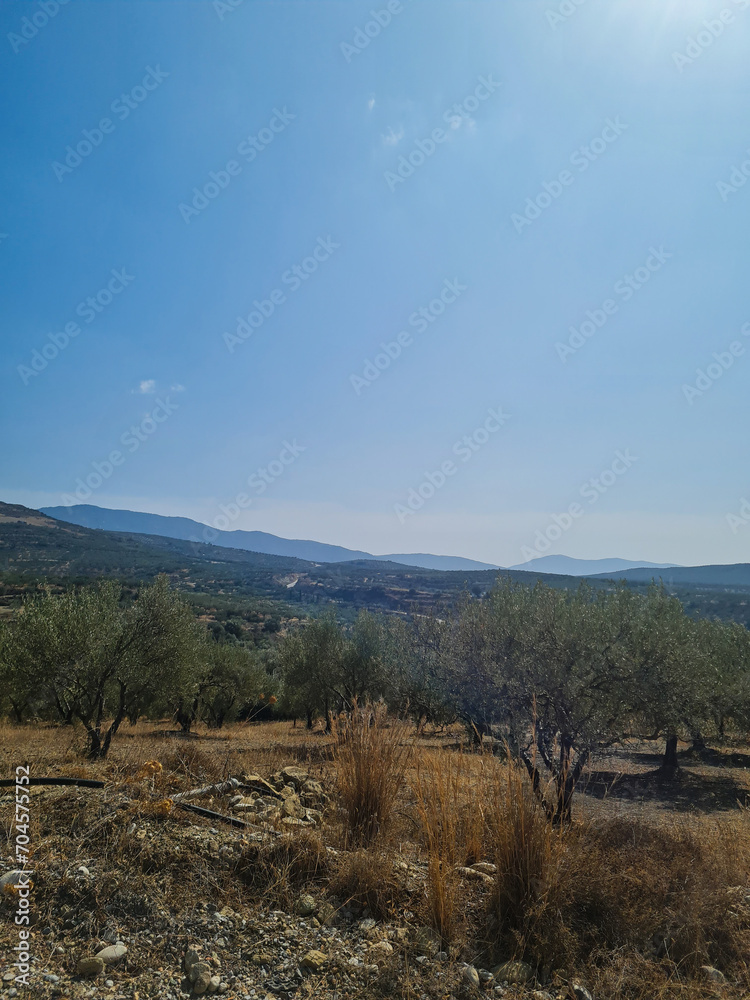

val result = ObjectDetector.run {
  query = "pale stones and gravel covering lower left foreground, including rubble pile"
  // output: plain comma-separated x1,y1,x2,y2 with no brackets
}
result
0,762,604,1000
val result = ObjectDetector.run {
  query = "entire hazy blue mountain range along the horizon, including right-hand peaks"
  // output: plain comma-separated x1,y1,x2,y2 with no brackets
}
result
41,504,688,579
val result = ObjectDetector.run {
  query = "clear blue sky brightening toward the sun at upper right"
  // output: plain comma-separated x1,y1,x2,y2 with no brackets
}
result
0,0,750,565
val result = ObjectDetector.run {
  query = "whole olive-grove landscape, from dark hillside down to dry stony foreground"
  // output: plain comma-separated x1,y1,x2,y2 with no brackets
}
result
0,511,750,1000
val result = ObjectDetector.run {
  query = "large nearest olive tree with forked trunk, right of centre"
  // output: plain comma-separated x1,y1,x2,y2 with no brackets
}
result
442,579,639,822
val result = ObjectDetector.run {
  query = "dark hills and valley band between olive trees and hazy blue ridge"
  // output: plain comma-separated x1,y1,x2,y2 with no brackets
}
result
5,501,750,627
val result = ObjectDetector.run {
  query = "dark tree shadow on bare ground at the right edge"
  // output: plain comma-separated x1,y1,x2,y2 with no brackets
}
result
579,758,750,812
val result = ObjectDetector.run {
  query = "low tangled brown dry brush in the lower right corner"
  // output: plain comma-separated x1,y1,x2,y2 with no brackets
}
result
560,818,750,977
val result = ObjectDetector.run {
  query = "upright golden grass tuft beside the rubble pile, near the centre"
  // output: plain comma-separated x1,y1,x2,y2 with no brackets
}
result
333,704,414,847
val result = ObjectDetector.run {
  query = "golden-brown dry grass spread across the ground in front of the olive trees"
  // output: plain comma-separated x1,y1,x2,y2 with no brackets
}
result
0,710,750,1000
